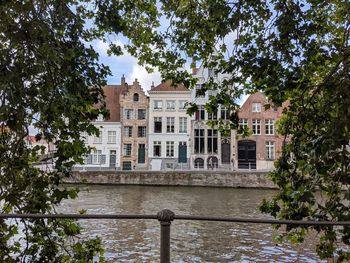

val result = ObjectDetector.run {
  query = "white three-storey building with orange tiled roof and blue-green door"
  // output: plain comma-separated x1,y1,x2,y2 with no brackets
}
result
148,81,191,170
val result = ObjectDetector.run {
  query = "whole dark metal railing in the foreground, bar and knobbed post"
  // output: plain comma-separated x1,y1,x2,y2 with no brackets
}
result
0,212,350,263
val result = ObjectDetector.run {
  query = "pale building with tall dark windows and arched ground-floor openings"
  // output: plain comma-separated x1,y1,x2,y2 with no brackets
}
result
190,60,235,170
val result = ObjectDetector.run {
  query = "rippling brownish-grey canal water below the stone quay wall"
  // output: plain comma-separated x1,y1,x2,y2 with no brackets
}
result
59,186,320,262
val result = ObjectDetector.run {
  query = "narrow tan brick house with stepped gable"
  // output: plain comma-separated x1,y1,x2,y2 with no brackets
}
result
120,79,149,170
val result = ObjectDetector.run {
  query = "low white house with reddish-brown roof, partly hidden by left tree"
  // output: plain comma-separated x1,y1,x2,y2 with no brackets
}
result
75,83,125,170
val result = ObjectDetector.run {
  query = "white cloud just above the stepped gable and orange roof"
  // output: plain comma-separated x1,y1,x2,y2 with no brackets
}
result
126,63,162,91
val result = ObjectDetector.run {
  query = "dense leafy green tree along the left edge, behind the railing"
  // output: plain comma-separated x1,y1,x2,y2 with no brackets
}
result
0,0,109,262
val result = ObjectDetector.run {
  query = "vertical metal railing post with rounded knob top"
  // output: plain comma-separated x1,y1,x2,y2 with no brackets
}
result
157,209,175,263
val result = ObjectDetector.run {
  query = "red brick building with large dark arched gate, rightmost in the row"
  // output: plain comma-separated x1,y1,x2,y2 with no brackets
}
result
235,92,284,170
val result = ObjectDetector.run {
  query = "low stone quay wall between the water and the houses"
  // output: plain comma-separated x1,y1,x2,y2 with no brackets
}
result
64,171,276,189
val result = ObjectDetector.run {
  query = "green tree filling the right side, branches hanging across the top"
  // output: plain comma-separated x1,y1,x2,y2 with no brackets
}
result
93,0,350,261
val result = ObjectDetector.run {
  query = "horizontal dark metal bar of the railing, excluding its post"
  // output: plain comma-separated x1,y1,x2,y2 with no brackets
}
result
0,214,350,226
